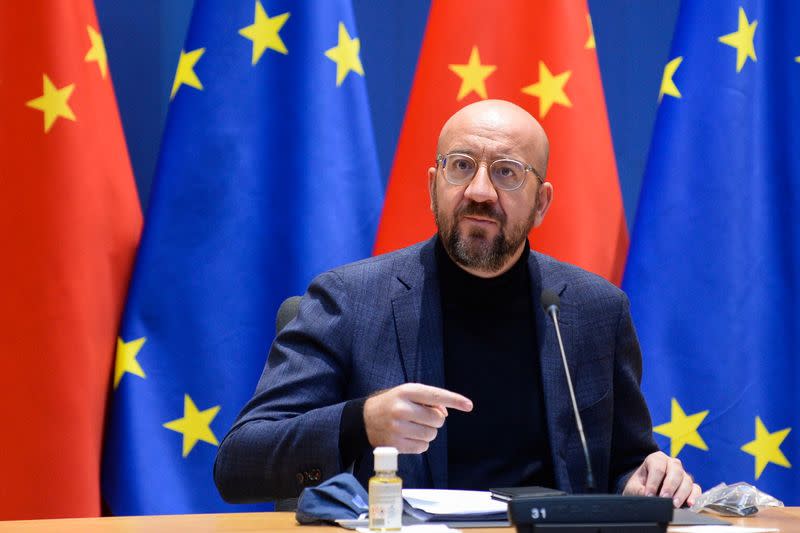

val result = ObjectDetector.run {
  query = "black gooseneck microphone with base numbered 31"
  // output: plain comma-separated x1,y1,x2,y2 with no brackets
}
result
508,289,673,533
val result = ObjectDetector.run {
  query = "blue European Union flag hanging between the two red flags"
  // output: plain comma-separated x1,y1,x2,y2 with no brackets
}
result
103,0,383,515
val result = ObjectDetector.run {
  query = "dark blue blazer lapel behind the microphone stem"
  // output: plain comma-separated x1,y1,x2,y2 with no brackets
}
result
528,254,575,492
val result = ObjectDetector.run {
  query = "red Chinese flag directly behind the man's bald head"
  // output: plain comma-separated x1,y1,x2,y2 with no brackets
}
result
375,0,628,284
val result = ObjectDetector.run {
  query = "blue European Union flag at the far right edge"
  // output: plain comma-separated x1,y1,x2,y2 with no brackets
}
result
623,0,800,505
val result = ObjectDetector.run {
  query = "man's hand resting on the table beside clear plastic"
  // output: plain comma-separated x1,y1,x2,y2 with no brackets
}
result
622,452,701,507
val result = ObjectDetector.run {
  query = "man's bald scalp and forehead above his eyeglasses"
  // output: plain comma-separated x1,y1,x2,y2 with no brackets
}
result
437,100,550,179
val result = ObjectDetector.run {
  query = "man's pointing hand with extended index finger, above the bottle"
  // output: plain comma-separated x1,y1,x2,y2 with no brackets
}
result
364,383,472,453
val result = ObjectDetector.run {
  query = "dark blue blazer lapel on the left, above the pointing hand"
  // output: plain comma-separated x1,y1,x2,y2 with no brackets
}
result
392,239,447,488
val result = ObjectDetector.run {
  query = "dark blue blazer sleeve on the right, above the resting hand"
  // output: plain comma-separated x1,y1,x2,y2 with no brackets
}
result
609,293,658,492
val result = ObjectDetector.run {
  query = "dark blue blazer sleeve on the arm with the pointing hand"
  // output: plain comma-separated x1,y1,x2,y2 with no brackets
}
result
214,272,353,503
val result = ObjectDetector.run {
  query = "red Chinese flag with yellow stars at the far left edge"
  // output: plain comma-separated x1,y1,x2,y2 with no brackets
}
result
0,0,142,519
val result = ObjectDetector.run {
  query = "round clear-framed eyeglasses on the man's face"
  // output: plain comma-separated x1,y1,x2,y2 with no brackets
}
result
436,153,544,191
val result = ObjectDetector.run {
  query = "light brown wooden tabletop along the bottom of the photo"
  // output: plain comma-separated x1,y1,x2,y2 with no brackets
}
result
0,507,800,533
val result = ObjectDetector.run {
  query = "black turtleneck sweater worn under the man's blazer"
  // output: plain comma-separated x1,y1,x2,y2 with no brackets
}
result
436,239,554,490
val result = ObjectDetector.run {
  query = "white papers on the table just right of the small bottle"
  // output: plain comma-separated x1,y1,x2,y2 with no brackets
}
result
403,489,508,517
